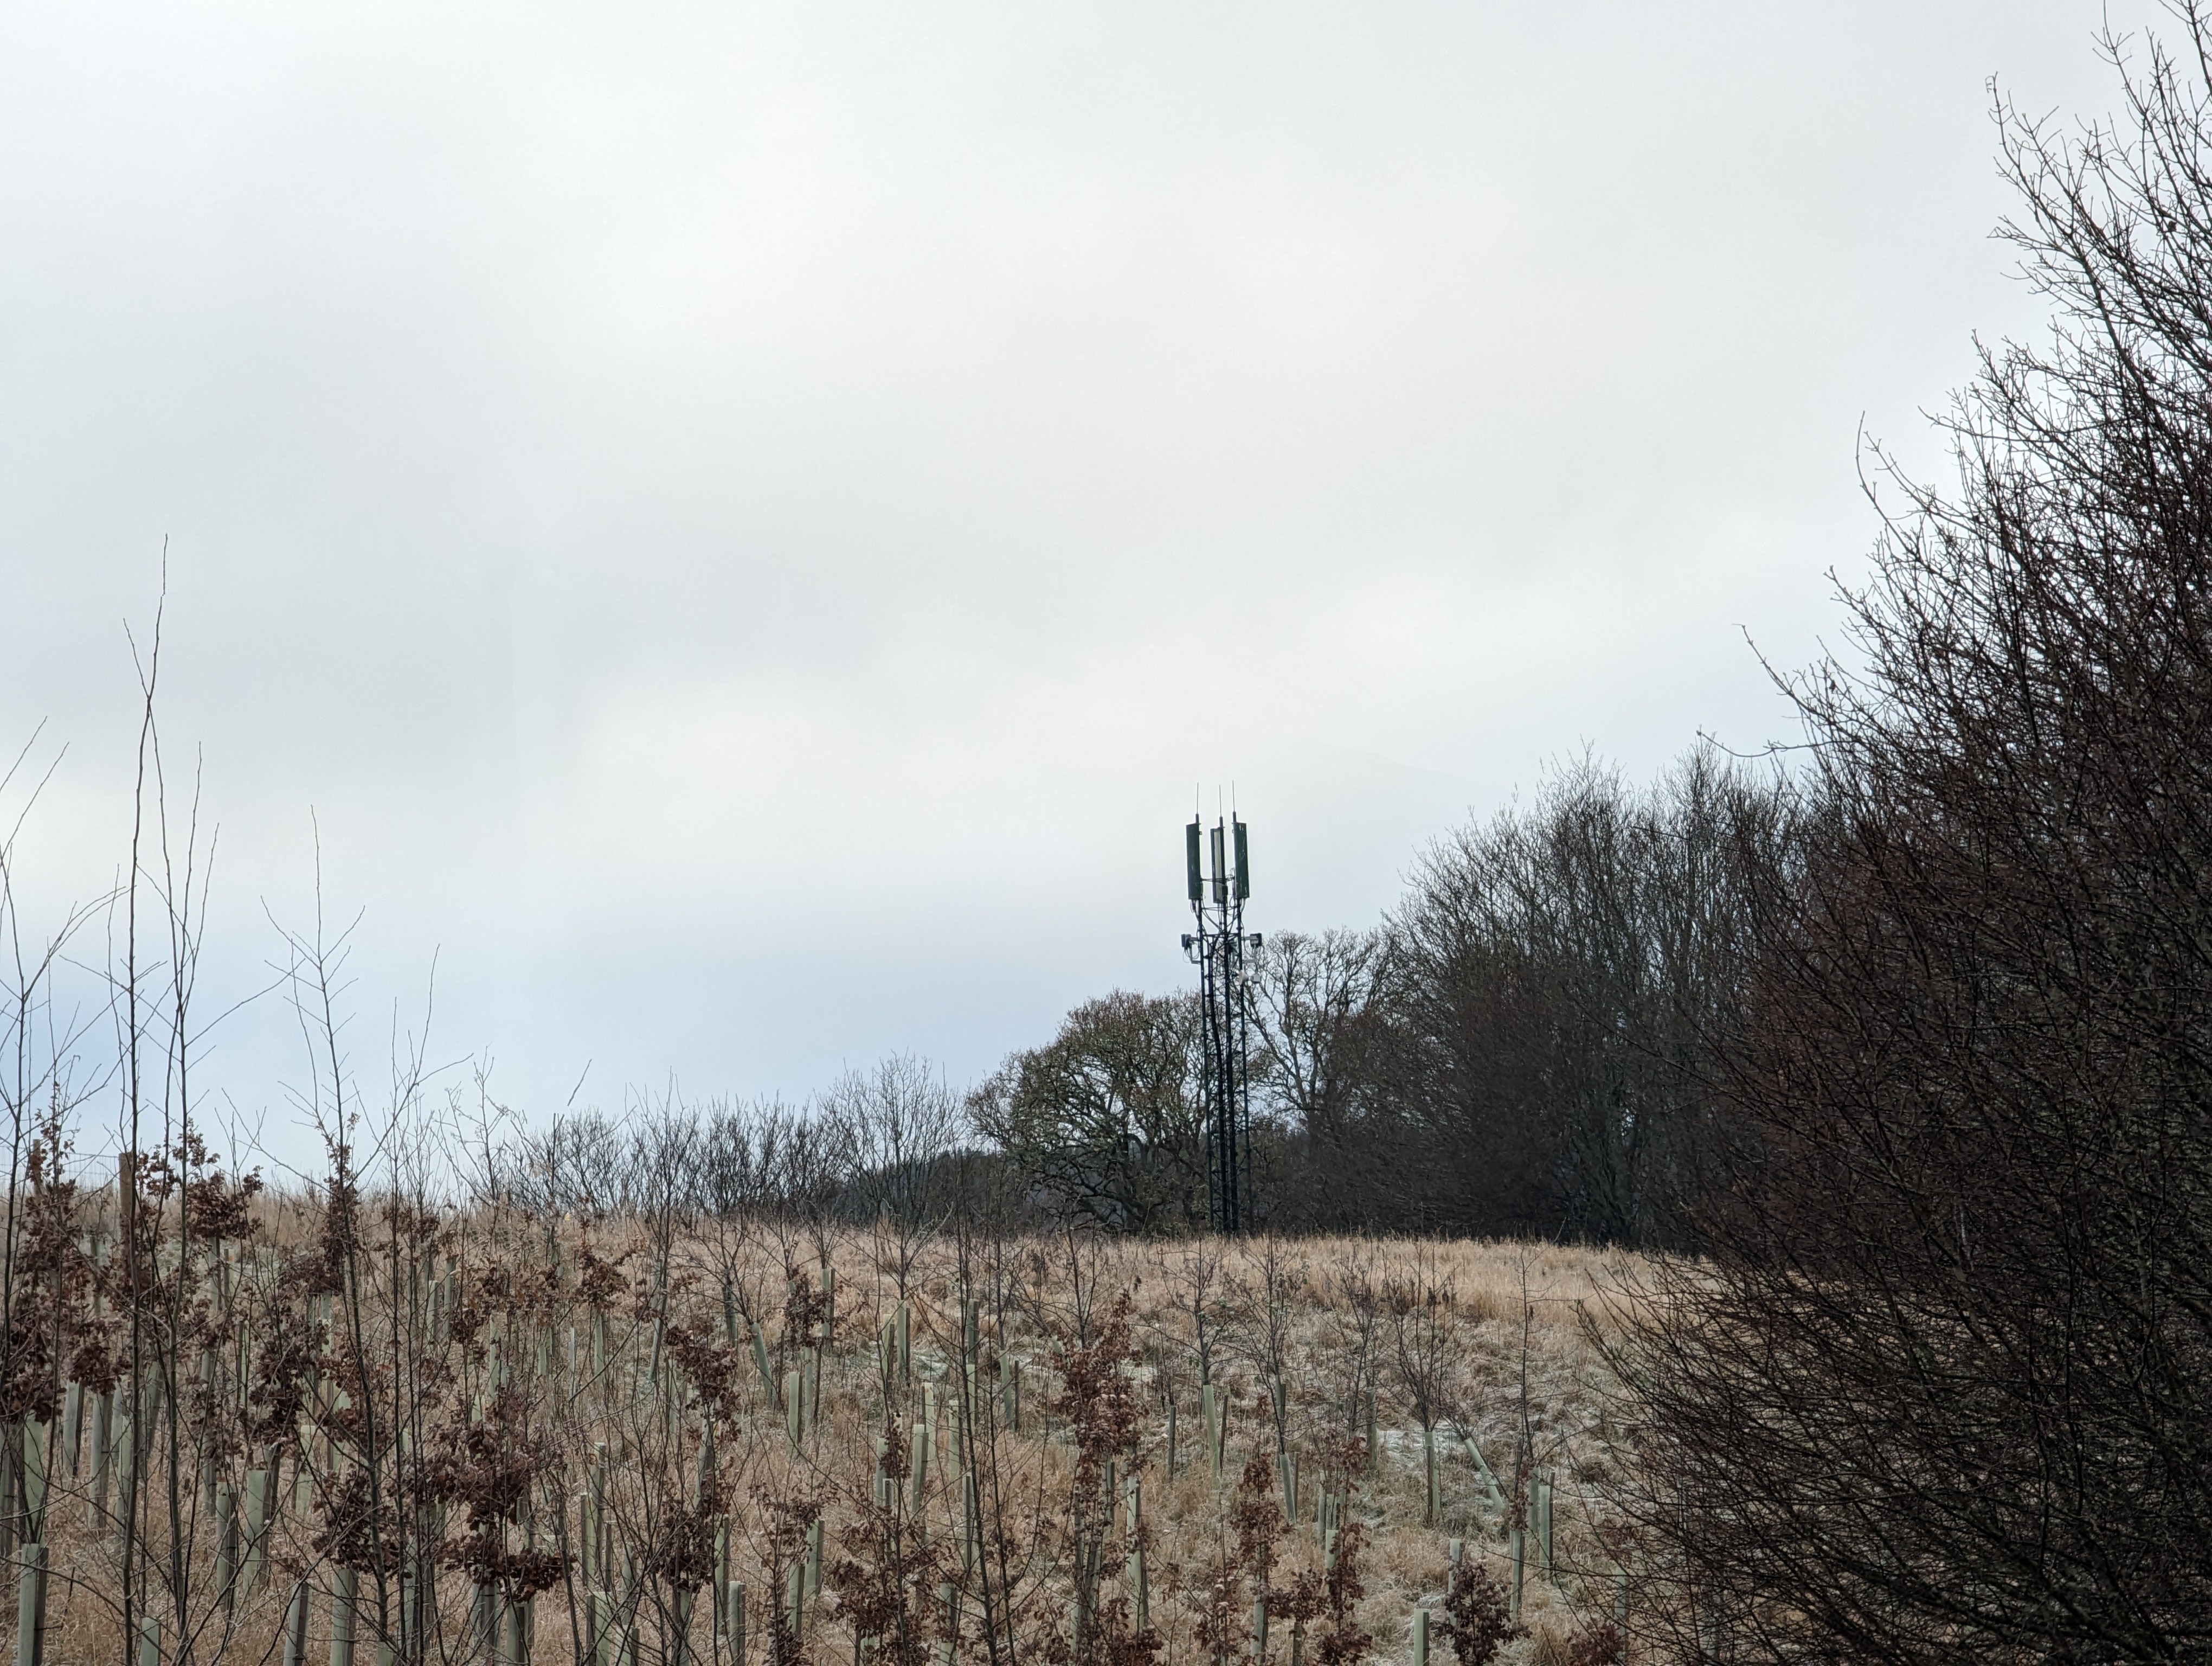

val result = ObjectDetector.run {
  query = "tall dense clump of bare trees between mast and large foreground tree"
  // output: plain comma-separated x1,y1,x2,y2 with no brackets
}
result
1387,748,1798,1246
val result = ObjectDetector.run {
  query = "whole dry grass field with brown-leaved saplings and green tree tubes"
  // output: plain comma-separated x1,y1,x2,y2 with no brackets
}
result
4,1184,1635,1666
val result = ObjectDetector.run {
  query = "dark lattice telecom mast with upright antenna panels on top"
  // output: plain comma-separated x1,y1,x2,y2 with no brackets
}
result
1184,814,1259,1232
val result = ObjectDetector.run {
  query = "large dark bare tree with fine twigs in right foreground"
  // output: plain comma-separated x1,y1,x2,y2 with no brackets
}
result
1619,16,2212,1662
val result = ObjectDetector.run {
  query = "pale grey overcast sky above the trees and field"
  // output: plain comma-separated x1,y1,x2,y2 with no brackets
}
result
0,0,2176,1142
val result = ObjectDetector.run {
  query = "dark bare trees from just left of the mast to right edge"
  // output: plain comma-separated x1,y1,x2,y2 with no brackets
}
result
978,12,2212,1662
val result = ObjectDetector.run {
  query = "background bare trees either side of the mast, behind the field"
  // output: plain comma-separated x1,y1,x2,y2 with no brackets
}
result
971,746,1814,1248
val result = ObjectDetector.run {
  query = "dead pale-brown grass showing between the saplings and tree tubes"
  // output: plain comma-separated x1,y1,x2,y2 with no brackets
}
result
4,1201,1637,1666
